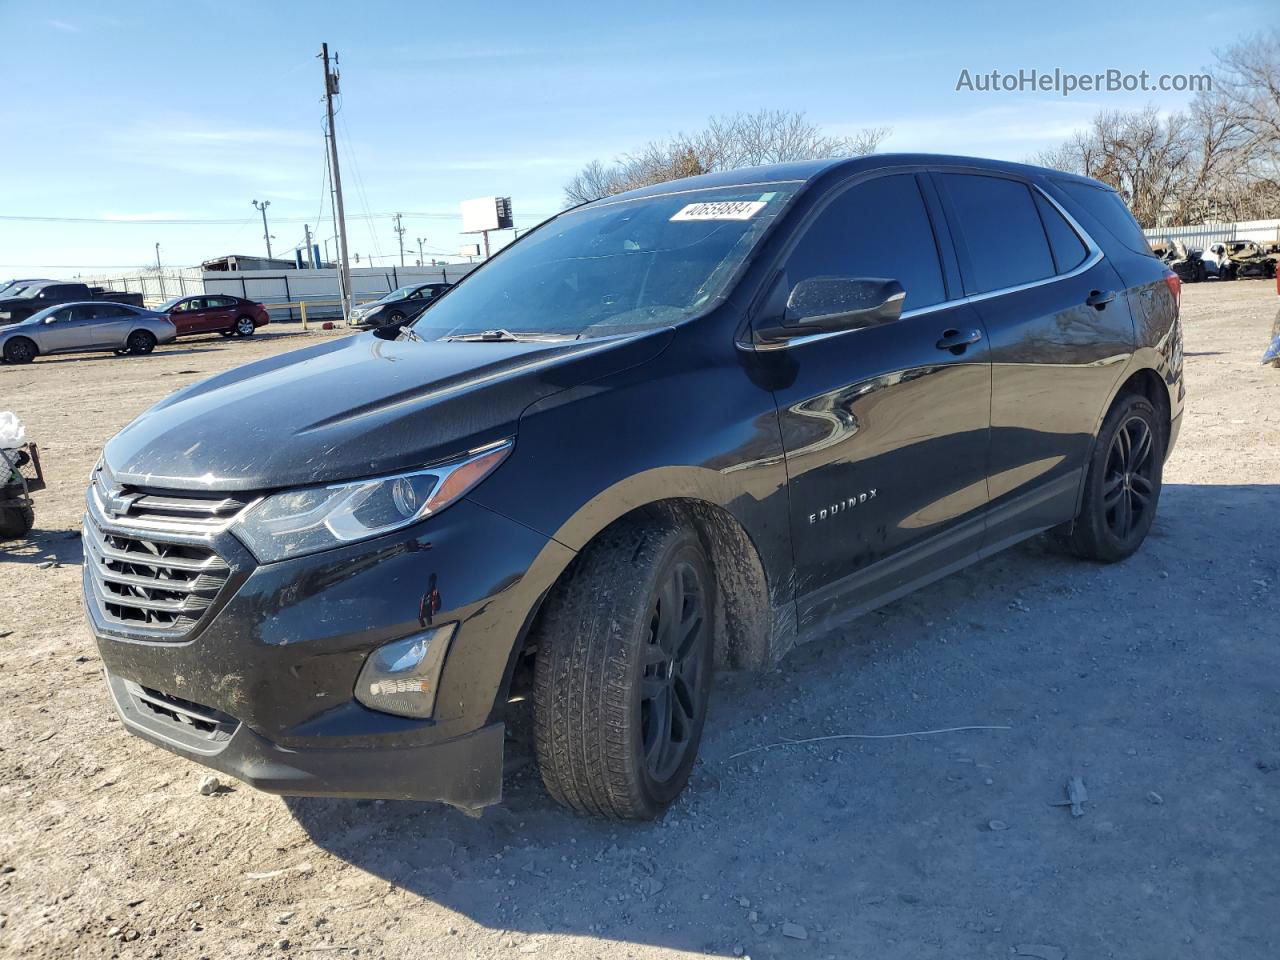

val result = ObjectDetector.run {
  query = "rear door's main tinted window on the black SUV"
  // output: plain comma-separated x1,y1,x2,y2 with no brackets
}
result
937,173,1055,293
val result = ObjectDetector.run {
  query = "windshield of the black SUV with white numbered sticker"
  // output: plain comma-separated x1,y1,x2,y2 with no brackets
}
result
415,183,799,339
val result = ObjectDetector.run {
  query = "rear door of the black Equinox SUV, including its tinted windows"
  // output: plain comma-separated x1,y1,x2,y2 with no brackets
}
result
934,172,1133,547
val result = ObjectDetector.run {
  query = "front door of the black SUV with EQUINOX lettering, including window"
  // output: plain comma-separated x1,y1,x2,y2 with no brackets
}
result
771,173,991,631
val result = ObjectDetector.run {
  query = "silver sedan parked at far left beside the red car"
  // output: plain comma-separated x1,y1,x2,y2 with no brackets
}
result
0,301,178,364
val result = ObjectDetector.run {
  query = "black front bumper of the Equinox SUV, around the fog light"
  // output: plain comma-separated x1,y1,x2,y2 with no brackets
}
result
84,499,572,809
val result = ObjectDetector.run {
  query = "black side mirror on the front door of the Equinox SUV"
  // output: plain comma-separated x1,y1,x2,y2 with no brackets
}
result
756,276,906,342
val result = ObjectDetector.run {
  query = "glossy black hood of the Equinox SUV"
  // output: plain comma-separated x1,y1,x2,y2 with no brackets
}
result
105,330,671,490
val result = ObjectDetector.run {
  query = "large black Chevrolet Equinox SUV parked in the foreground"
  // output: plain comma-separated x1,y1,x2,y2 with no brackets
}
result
84,155,1183,818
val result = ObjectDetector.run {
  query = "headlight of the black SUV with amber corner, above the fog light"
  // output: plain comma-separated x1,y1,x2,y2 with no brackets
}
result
232,439,512,563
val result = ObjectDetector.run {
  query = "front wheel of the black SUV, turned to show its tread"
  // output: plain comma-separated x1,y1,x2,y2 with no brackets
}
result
534,520,716,819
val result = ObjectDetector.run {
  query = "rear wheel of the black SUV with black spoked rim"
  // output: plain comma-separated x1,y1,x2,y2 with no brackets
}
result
1064,394,1165,563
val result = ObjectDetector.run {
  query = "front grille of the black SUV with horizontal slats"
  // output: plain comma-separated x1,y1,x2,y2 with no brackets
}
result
84,468,246,639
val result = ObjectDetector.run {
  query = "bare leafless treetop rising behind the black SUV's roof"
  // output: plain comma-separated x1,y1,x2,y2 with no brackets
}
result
564,110,888,204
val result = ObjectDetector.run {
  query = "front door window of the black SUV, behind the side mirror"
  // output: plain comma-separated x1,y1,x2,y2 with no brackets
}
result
787,174,946,310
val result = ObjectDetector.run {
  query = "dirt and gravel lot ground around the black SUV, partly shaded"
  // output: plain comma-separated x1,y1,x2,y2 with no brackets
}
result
0,289,1280,960
